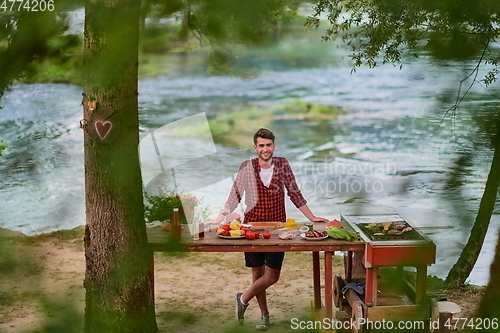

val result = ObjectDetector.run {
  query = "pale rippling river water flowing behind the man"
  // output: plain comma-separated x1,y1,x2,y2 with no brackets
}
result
0,31,500,284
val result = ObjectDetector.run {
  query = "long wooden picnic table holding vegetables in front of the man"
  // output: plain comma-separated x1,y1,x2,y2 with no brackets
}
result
147,223,365,318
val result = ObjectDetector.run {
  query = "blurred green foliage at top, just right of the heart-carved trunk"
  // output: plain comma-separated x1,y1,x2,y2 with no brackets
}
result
143,0,298,77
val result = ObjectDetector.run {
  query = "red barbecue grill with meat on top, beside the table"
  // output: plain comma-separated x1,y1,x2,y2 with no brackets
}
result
333,214,439,332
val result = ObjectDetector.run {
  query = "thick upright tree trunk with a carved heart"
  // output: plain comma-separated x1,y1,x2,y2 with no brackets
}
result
83,0,158,333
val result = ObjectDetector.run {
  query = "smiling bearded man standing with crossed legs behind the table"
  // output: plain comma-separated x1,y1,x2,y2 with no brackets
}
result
213,128,328,330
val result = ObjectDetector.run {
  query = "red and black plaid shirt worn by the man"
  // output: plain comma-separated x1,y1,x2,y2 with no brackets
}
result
226,157,307,223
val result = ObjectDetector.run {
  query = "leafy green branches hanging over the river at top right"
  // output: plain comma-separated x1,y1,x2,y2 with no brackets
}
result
306,0,500,84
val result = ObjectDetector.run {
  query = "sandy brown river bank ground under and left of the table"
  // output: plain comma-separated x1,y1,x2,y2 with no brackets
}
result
0,227,483,333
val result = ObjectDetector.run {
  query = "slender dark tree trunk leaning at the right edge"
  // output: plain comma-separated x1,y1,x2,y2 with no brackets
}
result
445,118,500,288
